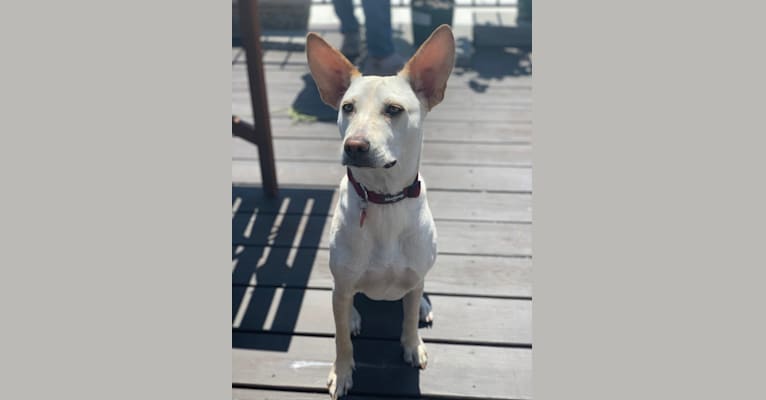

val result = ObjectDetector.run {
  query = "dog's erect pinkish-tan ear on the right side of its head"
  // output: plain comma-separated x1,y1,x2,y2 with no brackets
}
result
399,25,455,111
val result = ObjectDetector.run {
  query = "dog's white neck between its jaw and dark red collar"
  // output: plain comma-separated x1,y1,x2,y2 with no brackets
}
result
349,155,420,194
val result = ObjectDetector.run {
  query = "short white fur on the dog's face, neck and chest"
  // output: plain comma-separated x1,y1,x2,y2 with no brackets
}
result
330,76,436,300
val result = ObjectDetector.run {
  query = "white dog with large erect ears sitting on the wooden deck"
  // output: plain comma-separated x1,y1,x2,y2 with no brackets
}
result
306,25,455,400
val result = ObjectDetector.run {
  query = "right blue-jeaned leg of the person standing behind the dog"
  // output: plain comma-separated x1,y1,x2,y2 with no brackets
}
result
362,0,394,58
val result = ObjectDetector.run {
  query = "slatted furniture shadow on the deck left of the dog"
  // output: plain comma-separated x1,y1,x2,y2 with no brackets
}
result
231,186,333,351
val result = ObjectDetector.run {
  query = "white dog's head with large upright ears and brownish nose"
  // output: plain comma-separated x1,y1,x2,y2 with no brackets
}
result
306,25,455,168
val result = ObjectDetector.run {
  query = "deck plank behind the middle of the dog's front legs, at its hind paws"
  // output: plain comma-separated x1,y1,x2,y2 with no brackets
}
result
232,286,532,346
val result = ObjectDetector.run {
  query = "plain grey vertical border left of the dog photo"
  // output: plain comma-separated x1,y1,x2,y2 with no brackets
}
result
0,0,231,400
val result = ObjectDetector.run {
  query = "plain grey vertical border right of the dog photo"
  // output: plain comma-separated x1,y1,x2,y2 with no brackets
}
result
534,1,766,400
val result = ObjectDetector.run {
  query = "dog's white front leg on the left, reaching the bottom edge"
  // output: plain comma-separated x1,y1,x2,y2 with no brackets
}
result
327,288,354,400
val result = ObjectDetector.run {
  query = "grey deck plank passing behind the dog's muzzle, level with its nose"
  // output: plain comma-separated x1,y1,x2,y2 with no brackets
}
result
232,137,532,167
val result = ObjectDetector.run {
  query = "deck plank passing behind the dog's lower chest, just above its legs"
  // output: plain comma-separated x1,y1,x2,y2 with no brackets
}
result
232,245,532,298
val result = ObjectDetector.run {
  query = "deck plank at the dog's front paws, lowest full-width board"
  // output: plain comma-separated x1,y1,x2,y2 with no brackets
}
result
232,332,532,399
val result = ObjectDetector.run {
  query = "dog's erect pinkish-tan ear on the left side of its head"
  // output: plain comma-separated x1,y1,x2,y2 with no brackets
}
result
306,32,361,110
